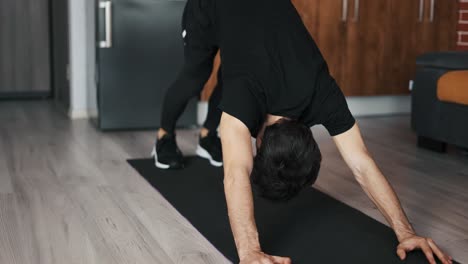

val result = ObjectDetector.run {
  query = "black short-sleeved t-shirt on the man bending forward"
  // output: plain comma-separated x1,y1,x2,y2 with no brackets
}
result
193,0,355,137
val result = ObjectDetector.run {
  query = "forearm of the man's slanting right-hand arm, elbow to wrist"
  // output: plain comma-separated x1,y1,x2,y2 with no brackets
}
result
356,161,414,241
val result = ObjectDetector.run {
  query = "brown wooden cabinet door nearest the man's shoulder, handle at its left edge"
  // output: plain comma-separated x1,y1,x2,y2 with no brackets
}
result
342,0,392,95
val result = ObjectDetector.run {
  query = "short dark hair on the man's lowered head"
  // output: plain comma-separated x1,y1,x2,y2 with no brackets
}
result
251,119,322,201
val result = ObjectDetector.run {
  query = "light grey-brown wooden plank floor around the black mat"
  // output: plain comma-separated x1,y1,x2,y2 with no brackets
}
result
0,101,468,264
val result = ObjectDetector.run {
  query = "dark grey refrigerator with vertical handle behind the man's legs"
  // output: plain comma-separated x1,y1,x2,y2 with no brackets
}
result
94,0,197,130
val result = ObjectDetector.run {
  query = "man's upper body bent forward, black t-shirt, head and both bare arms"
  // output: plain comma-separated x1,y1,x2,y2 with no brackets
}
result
216,0,458,264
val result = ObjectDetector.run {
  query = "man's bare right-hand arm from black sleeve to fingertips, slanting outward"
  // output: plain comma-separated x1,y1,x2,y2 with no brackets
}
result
333,124,452,264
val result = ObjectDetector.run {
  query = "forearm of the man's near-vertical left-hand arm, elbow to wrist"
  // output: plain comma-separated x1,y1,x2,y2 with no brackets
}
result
224,171,260,259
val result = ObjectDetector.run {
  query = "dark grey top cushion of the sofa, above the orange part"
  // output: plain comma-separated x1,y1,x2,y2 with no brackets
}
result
416,51,468,70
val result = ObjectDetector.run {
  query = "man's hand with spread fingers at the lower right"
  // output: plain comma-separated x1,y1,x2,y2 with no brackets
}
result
397,235,452,264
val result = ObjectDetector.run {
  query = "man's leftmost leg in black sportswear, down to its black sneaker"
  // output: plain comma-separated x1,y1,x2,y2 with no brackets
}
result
153,0,218,169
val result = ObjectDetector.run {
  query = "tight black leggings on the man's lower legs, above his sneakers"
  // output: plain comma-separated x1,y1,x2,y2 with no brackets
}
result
161,46,222,134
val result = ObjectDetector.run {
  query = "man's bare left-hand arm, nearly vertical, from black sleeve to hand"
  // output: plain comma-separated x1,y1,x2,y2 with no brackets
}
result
220,113,290,264
